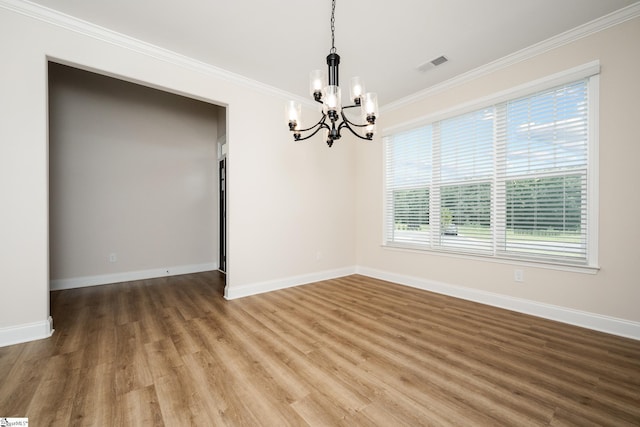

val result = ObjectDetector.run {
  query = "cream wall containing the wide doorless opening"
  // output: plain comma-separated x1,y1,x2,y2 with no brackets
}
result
0,2,355,345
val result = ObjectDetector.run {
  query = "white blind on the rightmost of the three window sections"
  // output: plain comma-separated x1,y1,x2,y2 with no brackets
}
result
496,80,588,262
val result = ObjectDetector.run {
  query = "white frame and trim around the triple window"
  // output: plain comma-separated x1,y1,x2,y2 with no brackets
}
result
382,61,600,273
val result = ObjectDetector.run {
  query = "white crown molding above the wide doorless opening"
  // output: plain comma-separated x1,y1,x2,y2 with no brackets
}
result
0,0,315,106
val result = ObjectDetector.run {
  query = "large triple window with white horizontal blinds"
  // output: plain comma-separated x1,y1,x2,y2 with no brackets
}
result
384,67,597,266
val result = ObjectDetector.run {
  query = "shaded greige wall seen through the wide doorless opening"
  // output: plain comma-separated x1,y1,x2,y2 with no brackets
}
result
49,63,224,288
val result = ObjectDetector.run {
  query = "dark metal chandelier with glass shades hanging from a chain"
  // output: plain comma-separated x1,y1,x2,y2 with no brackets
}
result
286,0,378,147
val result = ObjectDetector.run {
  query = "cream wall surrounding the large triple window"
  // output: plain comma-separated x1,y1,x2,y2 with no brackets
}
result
356,18,640,333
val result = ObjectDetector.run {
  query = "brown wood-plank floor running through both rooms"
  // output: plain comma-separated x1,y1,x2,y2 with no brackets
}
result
0,272,640,427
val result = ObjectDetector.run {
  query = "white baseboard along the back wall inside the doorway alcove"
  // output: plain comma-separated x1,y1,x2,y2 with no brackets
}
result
49,262,218,291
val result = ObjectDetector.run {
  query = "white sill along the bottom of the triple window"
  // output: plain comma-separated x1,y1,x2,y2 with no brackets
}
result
381,244,600,274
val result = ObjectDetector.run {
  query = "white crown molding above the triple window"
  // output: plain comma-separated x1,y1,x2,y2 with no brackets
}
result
380,2,640,112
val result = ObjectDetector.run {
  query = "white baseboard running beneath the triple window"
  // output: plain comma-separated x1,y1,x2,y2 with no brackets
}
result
356,267,640,340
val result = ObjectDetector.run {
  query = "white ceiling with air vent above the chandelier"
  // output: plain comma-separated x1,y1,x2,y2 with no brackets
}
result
27,0,640,105
